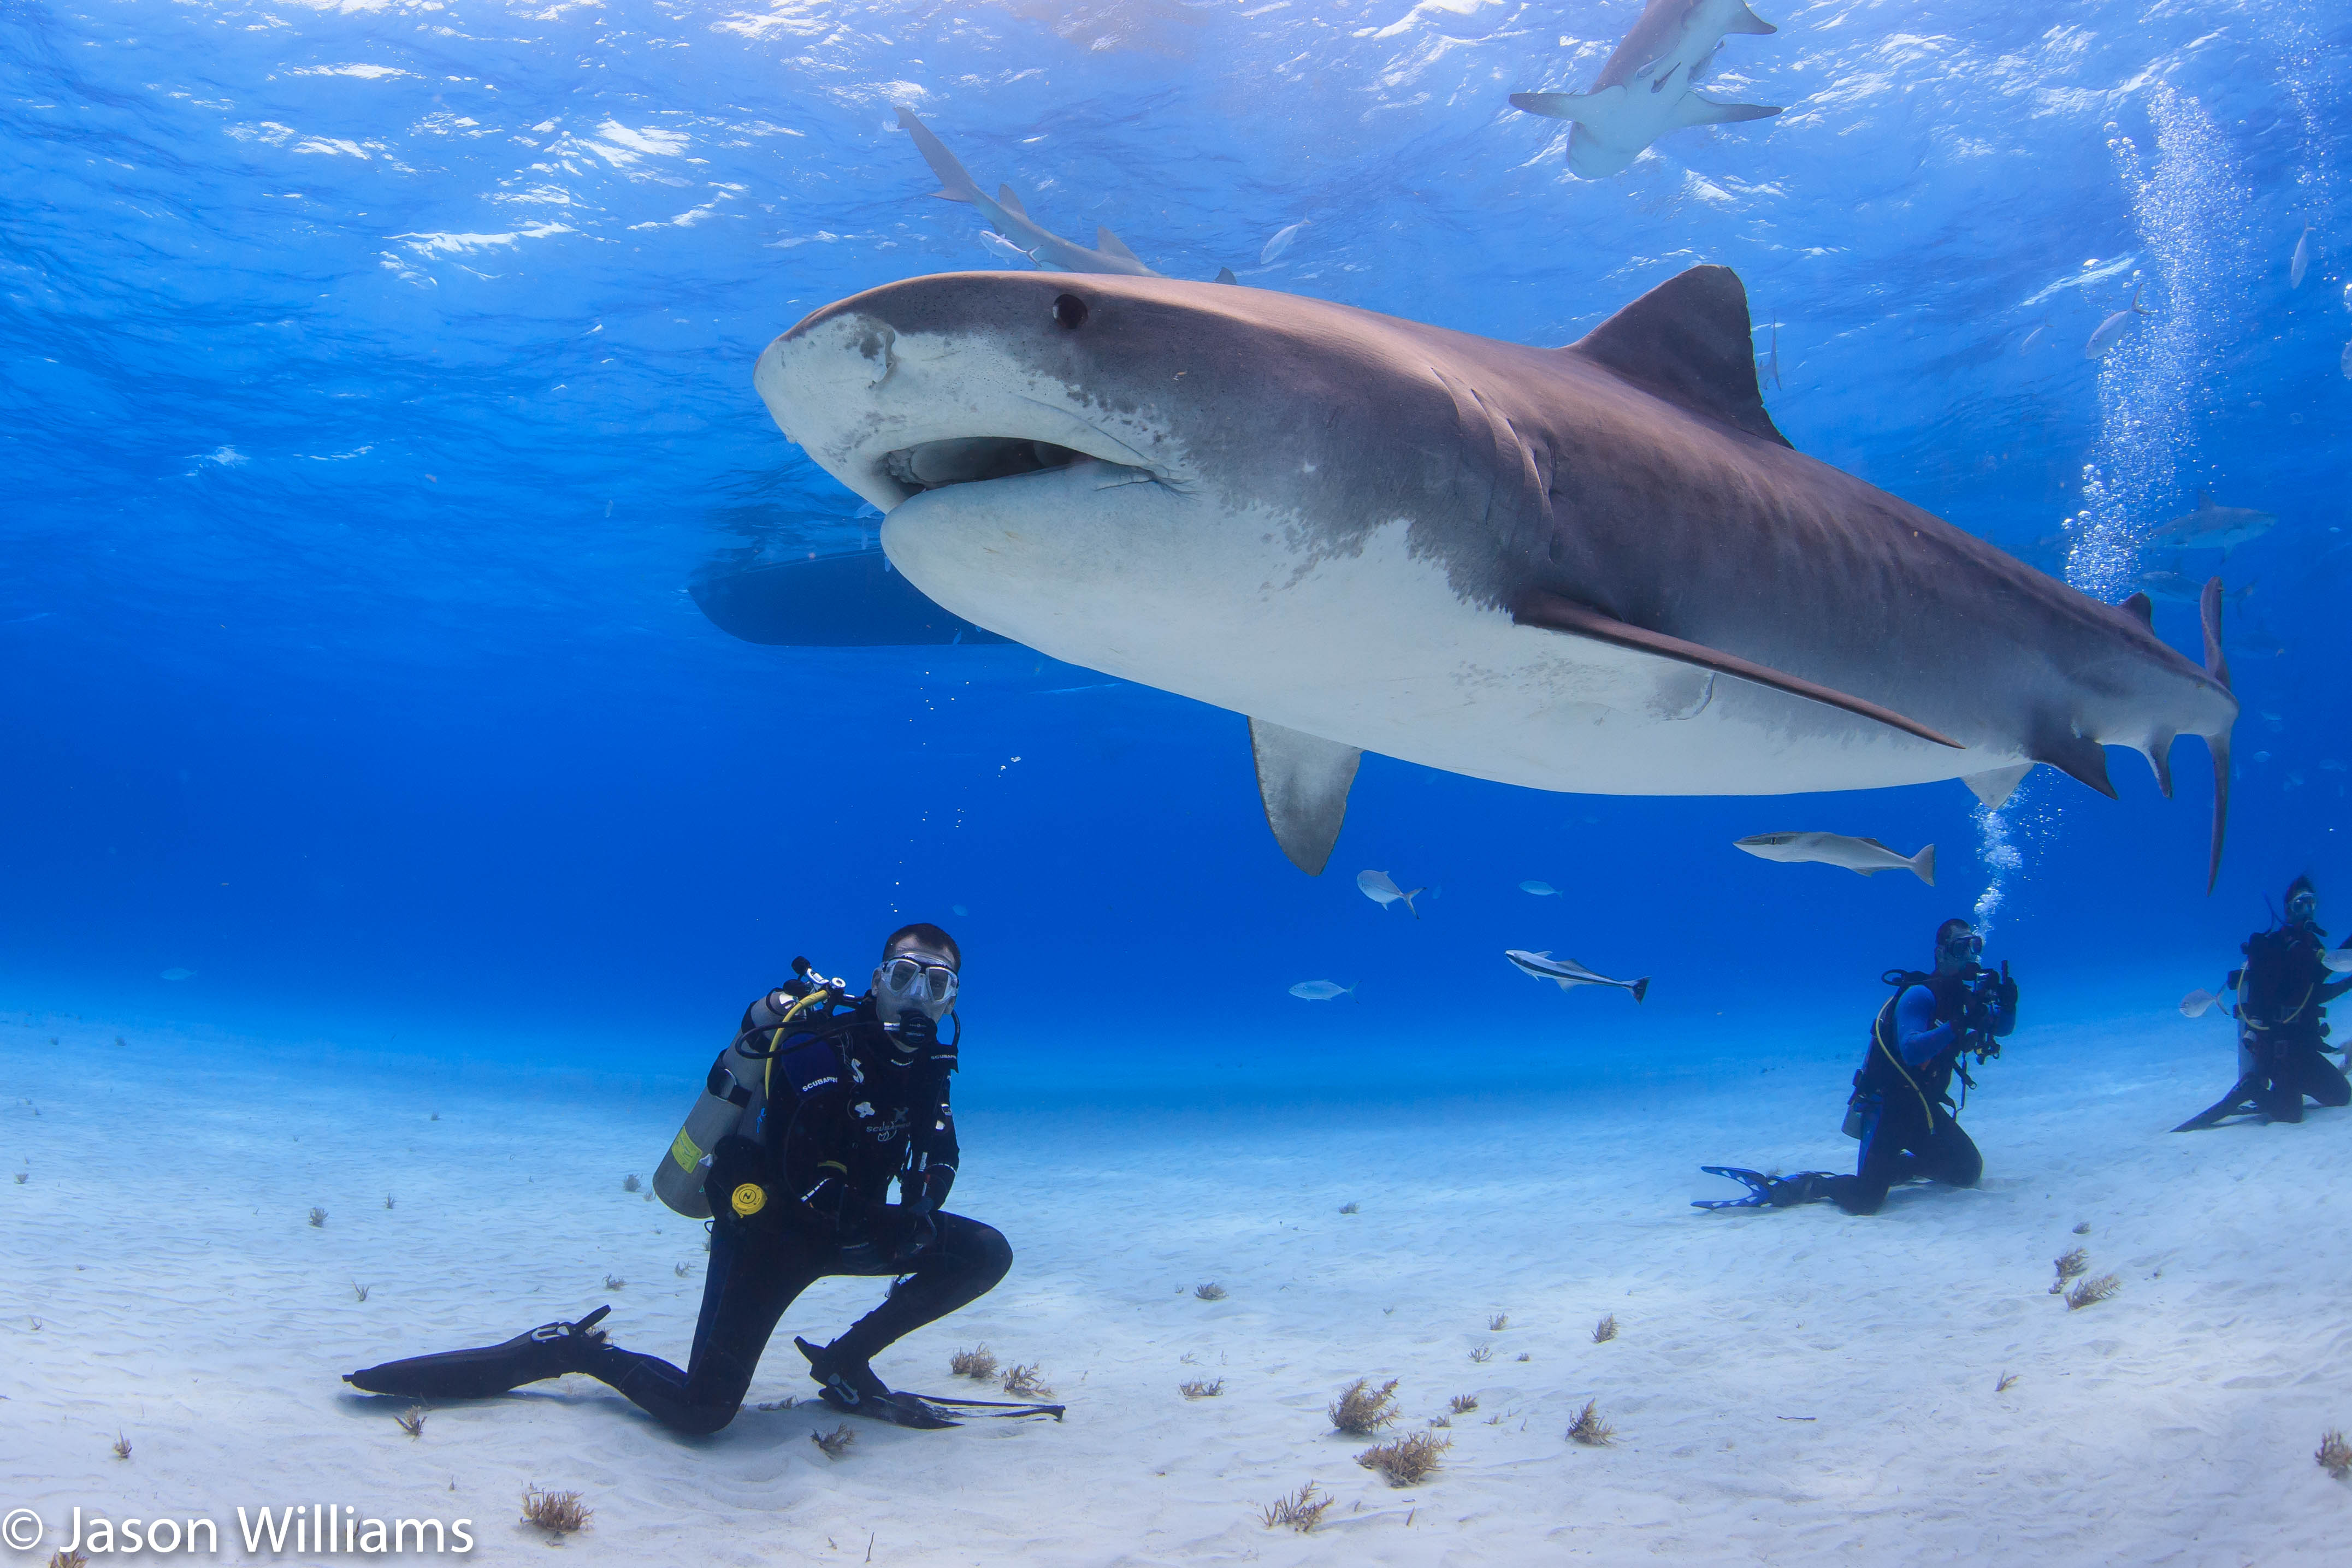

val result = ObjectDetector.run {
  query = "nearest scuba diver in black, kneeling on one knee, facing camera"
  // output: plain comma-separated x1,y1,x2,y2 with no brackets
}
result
346,924,1025,1434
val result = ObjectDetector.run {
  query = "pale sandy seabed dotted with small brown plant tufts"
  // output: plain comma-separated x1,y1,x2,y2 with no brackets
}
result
0,1015,2352,1568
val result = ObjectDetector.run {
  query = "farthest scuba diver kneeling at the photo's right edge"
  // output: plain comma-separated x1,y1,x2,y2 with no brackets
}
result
2173,877,2352,1133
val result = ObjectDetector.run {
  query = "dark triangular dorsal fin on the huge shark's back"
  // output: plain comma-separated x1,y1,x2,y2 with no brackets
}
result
1564,265,1788,447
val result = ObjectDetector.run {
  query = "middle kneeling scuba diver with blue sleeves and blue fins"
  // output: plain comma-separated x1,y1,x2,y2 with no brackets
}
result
1693,919,2018,1213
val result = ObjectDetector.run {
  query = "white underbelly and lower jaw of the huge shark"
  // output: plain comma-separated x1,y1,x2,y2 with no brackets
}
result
882,465,2008,795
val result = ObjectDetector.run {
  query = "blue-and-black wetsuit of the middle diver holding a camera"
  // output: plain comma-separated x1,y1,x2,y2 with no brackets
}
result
1821,966,2018,1213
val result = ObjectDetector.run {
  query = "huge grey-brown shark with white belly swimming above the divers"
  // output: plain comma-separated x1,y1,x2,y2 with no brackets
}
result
753,265,2237,889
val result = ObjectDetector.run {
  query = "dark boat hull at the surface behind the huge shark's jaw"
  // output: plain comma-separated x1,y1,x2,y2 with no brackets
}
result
687,550,1012,649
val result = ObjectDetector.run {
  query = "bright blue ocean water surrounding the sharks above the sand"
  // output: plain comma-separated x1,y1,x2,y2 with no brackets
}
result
0,0,2352,1098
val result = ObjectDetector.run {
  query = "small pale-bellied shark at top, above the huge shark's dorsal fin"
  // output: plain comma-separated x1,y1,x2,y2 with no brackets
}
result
1510,0,1781,179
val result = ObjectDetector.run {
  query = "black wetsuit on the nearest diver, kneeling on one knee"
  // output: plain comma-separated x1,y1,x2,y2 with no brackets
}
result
578,992,1014,1431
